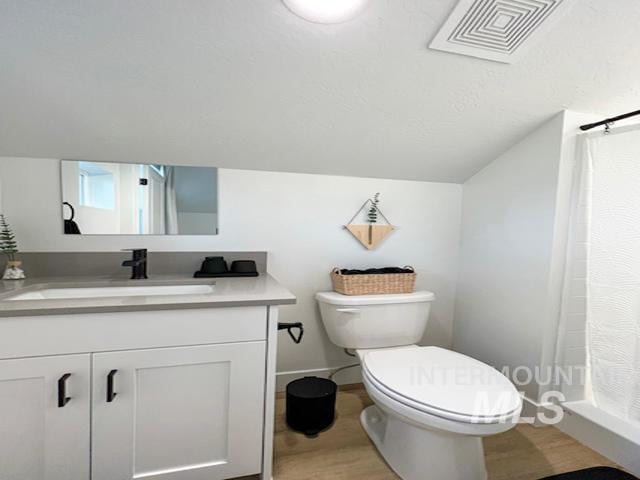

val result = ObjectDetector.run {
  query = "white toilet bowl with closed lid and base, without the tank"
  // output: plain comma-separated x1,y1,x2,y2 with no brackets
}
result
359,347,522,480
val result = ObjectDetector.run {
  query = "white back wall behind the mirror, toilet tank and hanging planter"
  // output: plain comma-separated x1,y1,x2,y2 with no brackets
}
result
0,158,462,384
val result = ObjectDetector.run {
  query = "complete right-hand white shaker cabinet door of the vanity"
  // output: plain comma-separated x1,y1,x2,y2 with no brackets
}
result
92,342,265,480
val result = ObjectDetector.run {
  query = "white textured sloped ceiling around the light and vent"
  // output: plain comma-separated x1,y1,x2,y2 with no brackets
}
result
0,0,640,182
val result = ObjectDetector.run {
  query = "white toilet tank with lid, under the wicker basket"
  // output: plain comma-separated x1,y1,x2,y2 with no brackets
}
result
316,292,435,349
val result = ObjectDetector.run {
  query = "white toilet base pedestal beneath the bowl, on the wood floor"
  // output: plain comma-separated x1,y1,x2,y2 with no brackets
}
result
360,405,487,480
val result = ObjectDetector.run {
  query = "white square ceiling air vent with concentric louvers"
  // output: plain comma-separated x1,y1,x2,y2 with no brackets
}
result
429,0,574,63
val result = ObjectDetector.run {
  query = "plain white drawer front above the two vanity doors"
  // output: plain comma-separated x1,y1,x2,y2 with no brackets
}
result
0,307,267,359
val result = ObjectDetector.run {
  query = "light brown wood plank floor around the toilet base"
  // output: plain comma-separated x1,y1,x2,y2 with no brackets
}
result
274,387,613,480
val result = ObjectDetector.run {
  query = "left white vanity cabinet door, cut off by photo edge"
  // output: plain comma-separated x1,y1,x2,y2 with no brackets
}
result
0,355,91,480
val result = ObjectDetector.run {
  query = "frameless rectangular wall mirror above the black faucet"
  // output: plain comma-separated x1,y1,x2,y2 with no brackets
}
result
61,160,218,235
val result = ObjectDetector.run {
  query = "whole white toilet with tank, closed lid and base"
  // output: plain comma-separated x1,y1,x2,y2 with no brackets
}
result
316,292,522,480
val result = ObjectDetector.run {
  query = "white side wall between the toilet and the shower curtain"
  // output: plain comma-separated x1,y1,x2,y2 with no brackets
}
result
454,112,592,402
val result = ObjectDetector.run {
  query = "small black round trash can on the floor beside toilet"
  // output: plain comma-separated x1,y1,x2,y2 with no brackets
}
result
286,377,338,436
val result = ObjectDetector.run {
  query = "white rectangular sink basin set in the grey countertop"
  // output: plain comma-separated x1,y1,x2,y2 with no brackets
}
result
7,285,214,300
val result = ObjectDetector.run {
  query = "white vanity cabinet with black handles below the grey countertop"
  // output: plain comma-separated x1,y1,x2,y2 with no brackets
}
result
0,306,277,480
